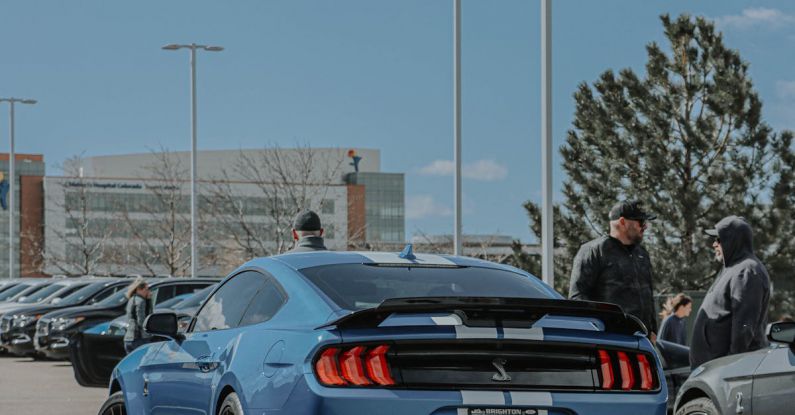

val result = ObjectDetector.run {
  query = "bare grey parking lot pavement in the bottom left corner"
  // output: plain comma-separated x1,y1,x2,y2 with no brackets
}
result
0,355,107,415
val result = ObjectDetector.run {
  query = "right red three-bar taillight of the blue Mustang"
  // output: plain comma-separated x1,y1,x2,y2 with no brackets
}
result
597,350,656,391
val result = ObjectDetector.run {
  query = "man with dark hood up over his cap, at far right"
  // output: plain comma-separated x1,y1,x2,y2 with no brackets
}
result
690,216,770,369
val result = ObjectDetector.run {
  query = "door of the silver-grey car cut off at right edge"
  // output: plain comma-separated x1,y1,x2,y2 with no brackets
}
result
751,346,795,415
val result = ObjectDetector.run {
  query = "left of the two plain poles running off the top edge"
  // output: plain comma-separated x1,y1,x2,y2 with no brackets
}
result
453,0,463,255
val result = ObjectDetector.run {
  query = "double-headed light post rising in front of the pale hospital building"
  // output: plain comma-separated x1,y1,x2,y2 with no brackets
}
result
163,43,224,277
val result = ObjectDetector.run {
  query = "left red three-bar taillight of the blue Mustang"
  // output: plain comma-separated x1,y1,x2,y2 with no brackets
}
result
315,344,395,386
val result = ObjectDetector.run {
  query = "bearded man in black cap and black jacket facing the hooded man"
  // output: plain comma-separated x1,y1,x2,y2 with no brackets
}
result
569,201,657,341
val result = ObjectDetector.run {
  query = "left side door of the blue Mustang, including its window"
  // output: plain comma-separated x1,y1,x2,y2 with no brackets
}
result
146,271,264,415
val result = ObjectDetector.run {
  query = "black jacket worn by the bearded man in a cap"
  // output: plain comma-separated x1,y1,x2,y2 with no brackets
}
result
569,235,657,333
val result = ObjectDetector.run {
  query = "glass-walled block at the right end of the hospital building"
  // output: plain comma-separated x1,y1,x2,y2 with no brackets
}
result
346,172,406,243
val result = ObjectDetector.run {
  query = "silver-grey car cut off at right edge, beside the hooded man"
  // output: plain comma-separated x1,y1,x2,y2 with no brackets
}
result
675,322,795,415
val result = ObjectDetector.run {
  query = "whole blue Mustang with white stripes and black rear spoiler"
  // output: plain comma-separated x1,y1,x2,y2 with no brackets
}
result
100,250,668,415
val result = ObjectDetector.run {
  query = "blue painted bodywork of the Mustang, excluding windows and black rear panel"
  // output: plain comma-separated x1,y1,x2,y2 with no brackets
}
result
105,252,667,415
